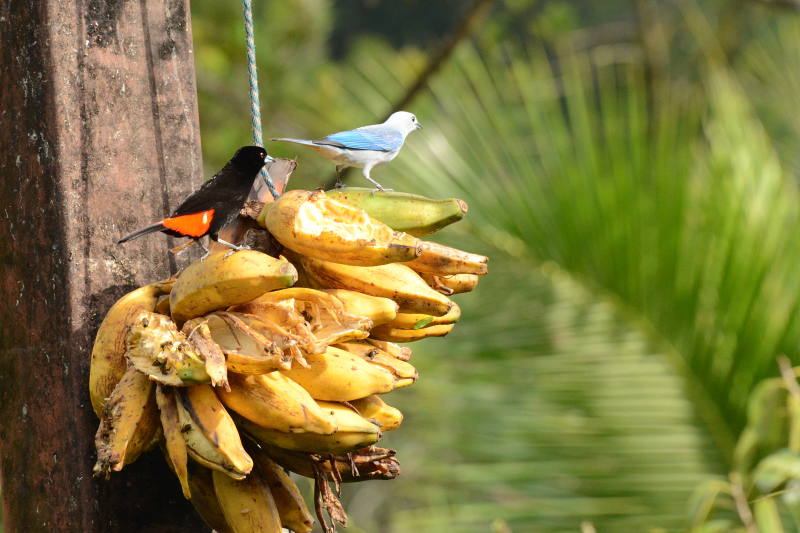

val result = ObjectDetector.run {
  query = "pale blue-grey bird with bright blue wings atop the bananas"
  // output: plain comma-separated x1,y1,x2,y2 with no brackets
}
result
272,111,422,191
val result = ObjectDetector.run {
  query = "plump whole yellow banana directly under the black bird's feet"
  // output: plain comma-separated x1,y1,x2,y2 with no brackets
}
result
170,250,297,326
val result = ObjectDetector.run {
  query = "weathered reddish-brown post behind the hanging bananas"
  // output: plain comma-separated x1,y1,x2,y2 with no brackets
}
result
0,0,208,533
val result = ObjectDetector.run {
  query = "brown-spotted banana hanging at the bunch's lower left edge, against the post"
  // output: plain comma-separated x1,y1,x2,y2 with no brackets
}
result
94,367,159,478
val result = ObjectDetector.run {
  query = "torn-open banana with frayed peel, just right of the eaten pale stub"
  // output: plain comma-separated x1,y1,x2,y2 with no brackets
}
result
184,316,292,374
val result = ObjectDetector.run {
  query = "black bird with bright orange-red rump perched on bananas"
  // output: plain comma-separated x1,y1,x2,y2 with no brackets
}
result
118,146,267,258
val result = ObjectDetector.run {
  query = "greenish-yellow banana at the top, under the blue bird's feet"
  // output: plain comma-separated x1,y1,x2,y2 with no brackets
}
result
326,187,467,237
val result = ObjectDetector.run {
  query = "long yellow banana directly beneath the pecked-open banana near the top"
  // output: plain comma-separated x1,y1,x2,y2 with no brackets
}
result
302,257,453,316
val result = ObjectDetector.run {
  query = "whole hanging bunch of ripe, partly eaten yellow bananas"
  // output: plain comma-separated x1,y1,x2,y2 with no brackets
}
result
90,189,487,533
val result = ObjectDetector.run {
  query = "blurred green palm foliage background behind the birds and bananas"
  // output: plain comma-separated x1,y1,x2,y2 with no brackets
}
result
192,0,800,533
